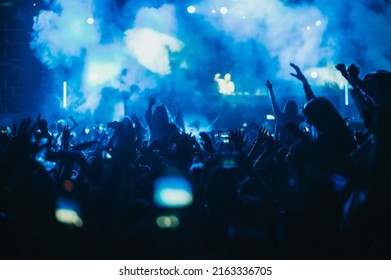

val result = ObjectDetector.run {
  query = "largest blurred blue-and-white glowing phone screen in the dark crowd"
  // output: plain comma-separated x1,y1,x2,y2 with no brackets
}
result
153,177,193,208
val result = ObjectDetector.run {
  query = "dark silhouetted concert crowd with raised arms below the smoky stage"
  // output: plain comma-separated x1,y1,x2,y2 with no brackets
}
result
0,64,391,259
